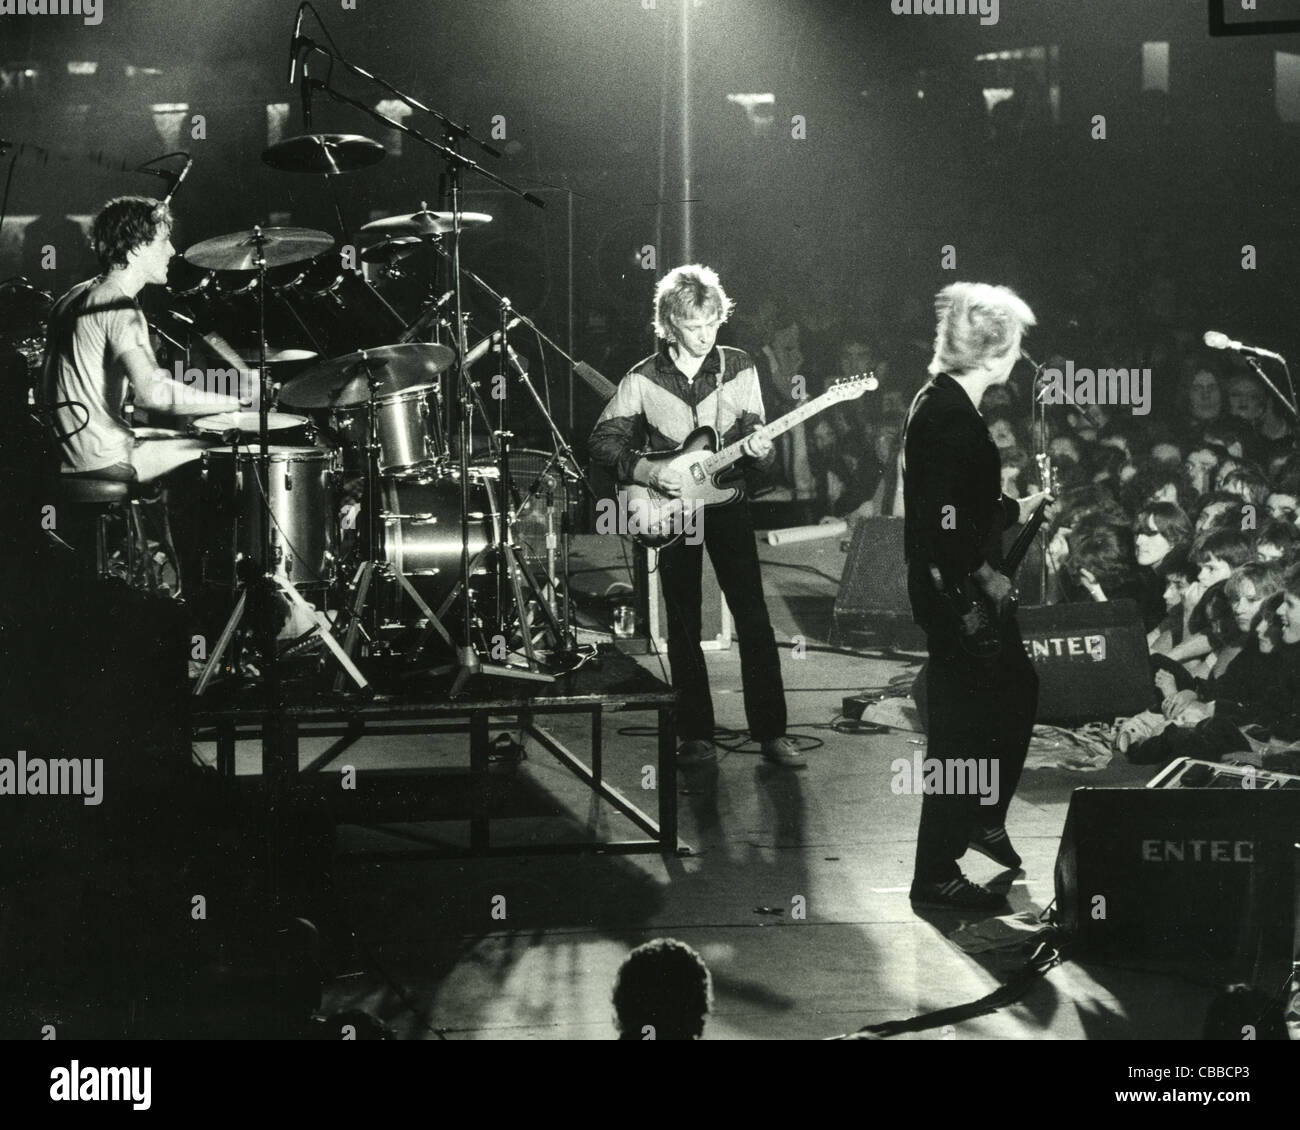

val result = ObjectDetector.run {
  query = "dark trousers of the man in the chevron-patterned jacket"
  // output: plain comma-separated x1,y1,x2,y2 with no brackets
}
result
659,499,785,741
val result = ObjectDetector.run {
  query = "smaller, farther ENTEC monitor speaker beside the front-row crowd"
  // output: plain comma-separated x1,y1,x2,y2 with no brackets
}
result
1018,601,1154,726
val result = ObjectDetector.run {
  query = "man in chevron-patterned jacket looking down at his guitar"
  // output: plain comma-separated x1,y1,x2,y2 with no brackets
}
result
589,264,806,769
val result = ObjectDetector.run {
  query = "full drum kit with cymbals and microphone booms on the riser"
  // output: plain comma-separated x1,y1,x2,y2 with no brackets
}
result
0,19,607,701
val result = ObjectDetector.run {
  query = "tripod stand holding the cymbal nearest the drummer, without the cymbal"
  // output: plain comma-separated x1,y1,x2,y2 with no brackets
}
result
194,226,371,710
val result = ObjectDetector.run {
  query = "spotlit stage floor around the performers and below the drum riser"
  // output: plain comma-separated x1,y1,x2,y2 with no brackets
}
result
200,538,1209,1039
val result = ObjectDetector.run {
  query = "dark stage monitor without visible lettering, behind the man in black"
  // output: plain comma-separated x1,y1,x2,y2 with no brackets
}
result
831,518,926,649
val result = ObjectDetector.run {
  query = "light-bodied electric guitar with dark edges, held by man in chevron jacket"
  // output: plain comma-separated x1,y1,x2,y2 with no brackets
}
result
619,373,879,549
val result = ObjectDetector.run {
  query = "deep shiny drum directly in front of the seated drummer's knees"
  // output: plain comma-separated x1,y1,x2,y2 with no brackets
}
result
203,445,338,588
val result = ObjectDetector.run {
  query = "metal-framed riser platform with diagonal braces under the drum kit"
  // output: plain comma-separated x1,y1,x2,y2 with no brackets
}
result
190,648,690,861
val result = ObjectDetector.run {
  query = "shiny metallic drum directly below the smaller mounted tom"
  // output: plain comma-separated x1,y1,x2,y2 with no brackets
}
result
378,468,498,612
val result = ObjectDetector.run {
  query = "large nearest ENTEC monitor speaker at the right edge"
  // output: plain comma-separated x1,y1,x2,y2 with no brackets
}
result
1056,788,1300,978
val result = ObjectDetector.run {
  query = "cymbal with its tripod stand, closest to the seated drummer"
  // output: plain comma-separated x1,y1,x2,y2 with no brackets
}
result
186,228,369,691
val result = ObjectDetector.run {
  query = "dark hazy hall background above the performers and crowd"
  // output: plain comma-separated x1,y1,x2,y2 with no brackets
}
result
0,0,1300,462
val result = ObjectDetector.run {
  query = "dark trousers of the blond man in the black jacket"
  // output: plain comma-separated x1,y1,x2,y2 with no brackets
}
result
914,618,1039,883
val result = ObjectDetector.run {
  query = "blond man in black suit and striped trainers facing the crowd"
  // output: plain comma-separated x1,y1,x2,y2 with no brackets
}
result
904,282,1047,910
